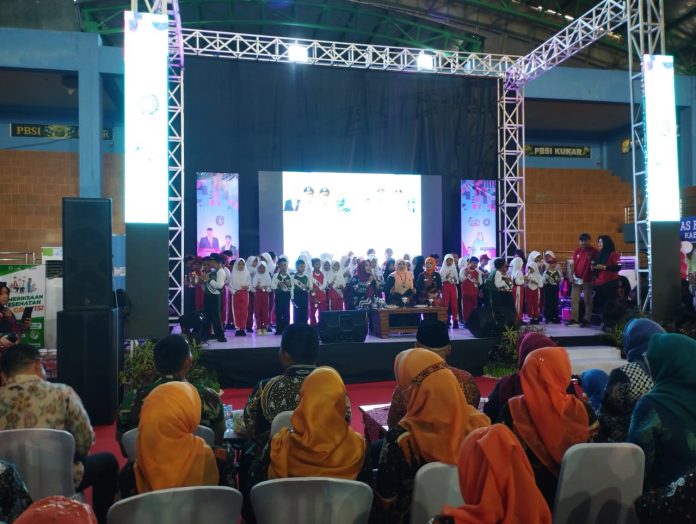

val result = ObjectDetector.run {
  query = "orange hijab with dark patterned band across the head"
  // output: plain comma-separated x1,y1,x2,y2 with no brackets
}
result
394,348,491,464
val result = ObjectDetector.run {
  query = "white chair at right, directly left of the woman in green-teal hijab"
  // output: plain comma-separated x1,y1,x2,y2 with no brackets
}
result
553,443,645,524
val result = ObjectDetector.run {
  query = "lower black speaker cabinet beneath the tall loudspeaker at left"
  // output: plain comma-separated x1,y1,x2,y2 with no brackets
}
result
58,309,123,425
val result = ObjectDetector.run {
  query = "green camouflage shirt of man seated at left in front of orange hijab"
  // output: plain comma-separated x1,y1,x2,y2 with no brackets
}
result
116,375,225,443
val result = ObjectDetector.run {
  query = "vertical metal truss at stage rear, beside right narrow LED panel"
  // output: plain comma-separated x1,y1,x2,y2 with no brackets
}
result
498,84,527,258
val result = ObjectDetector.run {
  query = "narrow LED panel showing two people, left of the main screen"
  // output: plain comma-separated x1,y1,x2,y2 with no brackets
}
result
196,173,239,256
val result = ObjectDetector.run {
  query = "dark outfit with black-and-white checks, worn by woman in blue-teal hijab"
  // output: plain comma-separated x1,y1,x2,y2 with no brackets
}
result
599,362,653,442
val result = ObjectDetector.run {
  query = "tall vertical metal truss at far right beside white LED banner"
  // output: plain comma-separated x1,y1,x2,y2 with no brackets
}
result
626,0,666,311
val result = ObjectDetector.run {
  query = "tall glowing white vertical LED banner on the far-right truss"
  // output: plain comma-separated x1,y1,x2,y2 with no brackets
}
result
643,55,679,222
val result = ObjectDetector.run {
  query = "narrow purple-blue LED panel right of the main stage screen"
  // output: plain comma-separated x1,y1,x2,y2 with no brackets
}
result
461,180,497,259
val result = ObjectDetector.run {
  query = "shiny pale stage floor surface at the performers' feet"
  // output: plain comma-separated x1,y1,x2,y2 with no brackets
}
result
198,324,604,351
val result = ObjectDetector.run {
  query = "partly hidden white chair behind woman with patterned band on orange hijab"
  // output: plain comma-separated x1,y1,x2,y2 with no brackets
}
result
411,462,464,524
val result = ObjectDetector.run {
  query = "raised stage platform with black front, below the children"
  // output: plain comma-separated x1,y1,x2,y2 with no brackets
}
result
201,324,622,387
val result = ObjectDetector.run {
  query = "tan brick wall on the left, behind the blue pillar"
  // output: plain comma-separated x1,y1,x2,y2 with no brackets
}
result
0,150,124,257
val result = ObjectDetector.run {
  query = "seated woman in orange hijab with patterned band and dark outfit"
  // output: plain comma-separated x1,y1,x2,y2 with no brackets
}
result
372,348,490,523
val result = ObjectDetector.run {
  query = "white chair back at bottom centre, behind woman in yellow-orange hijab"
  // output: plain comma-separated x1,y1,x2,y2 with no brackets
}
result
251,477,372,524
